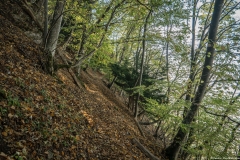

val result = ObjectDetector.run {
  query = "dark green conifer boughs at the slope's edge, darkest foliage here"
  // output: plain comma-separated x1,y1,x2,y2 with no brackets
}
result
110,60,166,103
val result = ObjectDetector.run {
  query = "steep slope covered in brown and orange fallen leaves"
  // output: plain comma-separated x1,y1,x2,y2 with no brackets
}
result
0,0,161,160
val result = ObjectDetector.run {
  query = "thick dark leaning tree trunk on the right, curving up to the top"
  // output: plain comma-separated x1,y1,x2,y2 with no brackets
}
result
165,0,224,160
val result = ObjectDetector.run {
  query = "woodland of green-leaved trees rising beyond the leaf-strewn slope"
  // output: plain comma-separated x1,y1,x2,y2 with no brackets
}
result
0,0,240,160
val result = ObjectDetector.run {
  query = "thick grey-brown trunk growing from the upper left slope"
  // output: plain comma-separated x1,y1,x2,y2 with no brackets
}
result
45,0,65,74
